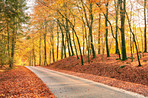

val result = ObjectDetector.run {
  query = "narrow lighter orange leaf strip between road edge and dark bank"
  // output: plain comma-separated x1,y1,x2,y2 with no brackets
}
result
44,67,148,96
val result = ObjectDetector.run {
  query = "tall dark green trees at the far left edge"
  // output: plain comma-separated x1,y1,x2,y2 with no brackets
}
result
0,0,27,68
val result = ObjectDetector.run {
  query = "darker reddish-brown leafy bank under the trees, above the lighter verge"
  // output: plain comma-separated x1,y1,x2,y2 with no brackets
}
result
44,54,148,85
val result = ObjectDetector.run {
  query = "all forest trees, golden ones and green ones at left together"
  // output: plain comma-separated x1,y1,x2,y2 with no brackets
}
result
0,0,148,66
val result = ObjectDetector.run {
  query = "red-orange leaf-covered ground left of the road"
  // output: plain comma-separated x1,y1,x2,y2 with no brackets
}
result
0,66,55,98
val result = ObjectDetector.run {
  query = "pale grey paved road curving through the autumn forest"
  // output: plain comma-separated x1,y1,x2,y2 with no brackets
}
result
26,66,146,98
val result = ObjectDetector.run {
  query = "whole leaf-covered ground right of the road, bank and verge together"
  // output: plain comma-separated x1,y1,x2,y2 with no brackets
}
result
42,53,148,96
